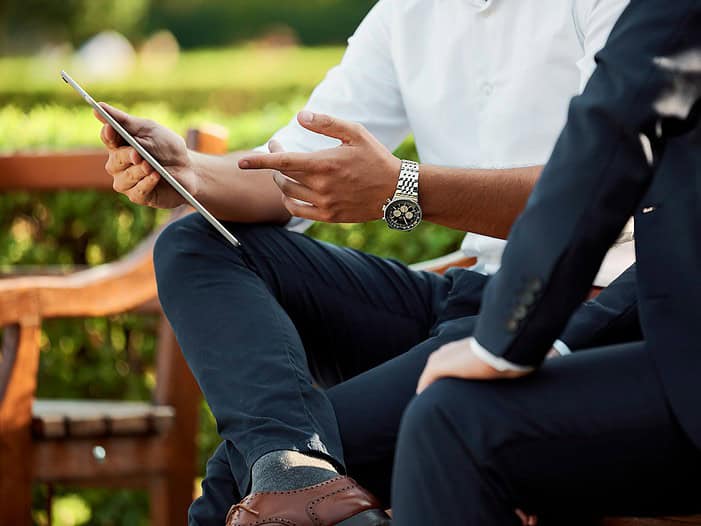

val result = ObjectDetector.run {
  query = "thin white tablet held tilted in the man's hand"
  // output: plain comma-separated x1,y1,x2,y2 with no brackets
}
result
61,71,241,247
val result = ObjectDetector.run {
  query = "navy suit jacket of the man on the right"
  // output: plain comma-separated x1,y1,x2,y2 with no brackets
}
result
474,0,701,447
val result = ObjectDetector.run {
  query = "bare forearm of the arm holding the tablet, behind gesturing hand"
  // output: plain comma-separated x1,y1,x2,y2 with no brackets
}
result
190,152,290,224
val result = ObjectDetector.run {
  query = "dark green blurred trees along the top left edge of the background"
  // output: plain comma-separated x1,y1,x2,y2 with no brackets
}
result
0,0,376,53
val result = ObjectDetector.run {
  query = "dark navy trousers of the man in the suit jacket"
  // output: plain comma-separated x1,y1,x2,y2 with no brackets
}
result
392,342,701,526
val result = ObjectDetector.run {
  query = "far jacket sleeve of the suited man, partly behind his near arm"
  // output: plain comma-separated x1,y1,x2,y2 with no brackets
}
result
560,265,643,352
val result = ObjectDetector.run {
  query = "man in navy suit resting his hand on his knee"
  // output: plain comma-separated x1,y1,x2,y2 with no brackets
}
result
393,0,701,526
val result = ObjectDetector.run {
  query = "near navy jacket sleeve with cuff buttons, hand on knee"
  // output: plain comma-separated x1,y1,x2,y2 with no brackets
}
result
474,0,701,366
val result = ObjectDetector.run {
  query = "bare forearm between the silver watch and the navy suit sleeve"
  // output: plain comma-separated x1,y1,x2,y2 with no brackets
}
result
420,165,543,239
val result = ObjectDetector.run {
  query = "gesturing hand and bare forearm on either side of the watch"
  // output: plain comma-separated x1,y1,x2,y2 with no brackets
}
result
239,111,541,230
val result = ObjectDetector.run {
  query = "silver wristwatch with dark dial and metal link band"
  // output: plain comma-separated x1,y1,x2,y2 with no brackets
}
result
382,161,423,231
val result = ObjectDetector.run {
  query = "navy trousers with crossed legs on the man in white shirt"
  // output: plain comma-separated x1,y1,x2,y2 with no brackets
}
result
154,214,486,526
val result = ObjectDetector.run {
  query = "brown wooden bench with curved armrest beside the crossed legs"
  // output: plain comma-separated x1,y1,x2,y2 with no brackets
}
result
0,131,226,526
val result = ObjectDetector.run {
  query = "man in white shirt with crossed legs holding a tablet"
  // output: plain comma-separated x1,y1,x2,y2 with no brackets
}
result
97,0,630,525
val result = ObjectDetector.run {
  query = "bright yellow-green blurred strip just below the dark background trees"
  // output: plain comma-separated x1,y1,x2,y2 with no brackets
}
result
0,46,343,113
